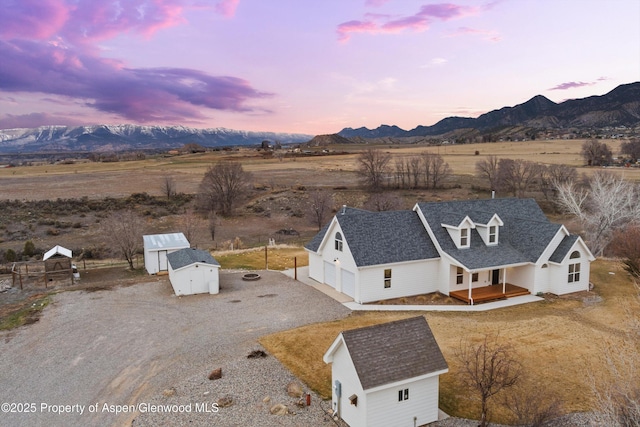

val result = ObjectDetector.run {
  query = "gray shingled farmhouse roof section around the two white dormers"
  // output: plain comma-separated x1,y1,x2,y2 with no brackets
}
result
418,199,561,270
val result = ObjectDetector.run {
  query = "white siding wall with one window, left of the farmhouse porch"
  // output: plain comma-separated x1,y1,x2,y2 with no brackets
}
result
356,260,439,303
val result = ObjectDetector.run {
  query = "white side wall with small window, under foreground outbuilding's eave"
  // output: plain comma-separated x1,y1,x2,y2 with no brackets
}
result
364,376,439,427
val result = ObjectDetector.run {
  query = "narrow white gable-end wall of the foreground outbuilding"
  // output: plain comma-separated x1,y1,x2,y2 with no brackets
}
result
331,345,367,427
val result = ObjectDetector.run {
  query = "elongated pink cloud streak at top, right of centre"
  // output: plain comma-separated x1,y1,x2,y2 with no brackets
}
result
337,3,479,41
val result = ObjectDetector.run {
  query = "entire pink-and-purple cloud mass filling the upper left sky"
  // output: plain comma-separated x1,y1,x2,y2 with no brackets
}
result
0,0,272,127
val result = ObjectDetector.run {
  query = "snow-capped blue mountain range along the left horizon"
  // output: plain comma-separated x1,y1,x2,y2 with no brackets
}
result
0,125,313,154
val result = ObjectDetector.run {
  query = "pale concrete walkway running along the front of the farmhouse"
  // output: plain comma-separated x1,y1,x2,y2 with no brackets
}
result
282,267,544,311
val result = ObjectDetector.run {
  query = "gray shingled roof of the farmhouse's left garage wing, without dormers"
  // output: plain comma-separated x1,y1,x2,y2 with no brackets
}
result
306,208,439,267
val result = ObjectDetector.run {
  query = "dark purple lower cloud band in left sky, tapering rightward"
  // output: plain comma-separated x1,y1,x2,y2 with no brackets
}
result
0,41,271,122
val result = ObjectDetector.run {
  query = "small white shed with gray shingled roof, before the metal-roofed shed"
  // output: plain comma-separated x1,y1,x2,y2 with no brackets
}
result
167,248,220,295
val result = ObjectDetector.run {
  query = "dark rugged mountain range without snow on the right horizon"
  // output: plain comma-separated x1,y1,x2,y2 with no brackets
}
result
338,82,640,138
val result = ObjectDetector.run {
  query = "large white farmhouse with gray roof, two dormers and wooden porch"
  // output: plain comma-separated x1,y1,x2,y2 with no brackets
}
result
306,198,595,304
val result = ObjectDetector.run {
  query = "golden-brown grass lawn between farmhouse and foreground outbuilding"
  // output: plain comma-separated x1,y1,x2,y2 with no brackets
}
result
260,260,640,422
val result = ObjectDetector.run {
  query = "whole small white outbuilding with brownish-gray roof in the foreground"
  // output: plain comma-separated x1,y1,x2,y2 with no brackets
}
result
323,316,449,427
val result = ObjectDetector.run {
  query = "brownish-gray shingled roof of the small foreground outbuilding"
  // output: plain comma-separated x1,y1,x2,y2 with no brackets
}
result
342,316,448,390
